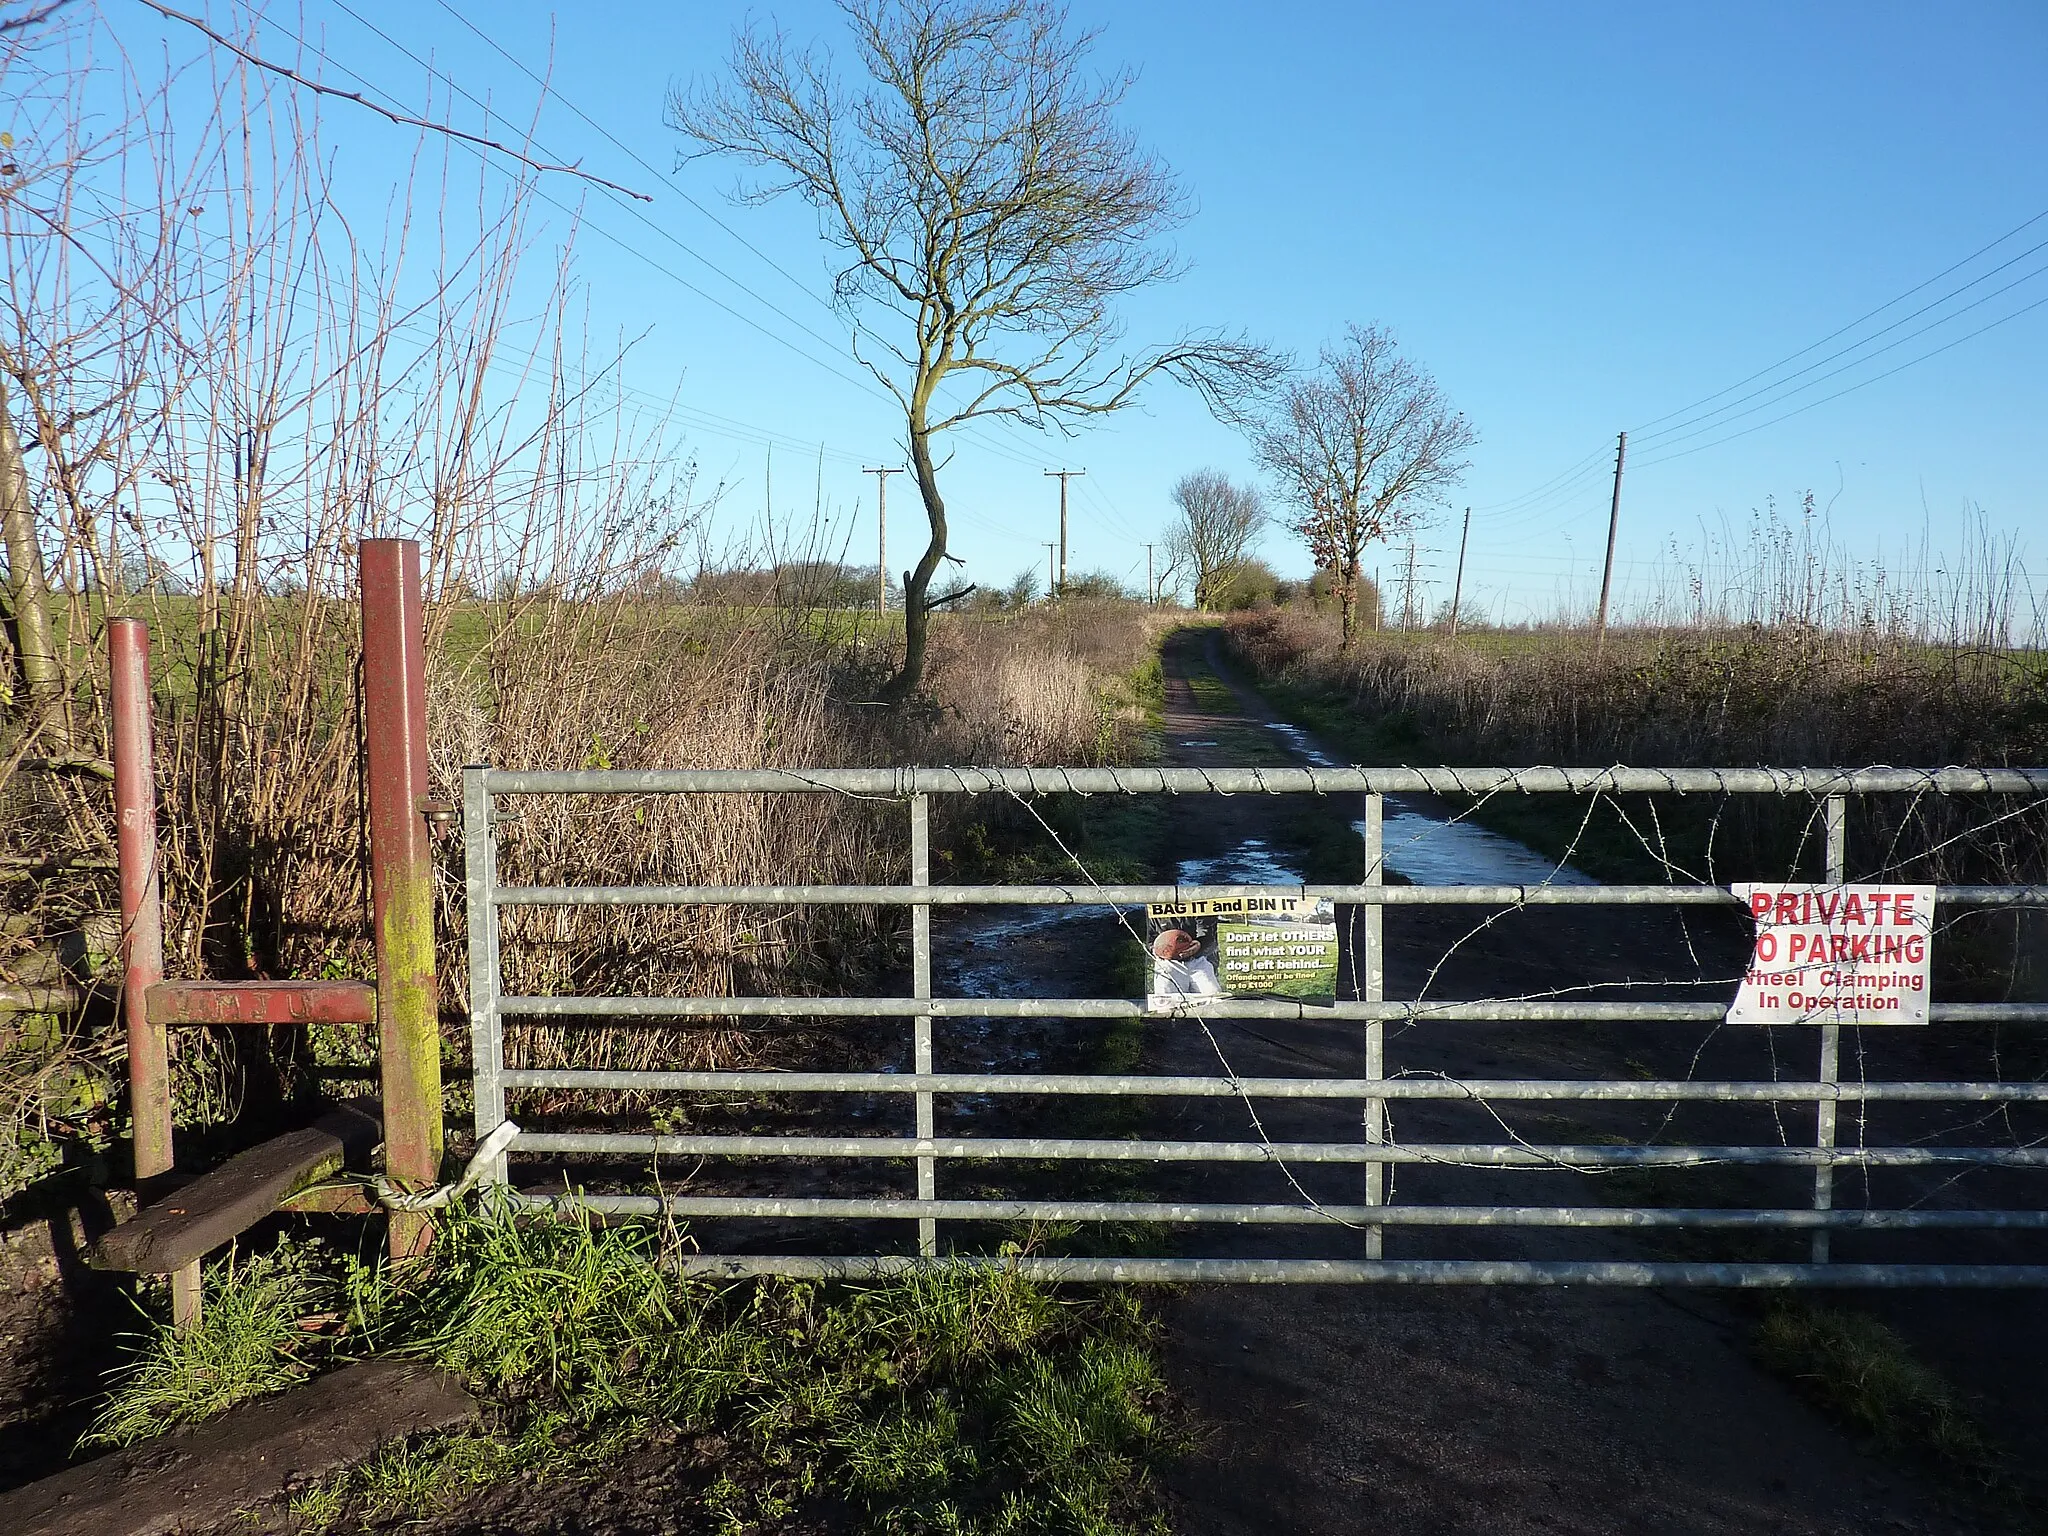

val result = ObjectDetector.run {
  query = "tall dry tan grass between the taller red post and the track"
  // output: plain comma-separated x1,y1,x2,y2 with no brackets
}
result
430,604,1157,1097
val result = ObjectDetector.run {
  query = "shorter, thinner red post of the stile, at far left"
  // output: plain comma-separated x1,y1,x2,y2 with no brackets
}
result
106,618,199,1327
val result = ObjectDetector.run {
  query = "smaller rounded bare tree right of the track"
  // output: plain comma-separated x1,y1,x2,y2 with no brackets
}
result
1251,326,1479,647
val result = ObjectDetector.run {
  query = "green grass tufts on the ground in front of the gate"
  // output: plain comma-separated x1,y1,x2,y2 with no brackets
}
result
96,1210,1174,1536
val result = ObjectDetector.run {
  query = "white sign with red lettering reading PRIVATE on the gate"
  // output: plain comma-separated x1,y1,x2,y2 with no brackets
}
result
1729,885,1933,1024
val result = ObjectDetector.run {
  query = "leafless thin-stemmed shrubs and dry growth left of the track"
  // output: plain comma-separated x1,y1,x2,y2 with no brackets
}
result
0,6,1171,1190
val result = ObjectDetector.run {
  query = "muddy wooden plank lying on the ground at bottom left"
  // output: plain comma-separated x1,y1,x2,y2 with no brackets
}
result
0,1360,477,1536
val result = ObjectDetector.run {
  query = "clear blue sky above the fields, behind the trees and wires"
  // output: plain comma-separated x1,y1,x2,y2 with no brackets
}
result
163,0,2048,618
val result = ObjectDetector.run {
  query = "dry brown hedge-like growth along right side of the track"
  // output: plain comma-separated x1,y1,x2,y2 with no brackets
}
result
1229,610,2048,879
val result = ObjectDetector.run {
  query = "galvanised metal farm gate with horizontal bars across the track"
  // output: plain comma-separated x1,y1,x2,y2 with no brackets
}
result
463,766,2048,1286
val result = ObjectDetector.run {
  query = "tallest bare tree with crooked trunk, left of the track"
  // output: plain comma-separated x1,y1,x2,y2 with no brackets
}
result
670,0,1272,702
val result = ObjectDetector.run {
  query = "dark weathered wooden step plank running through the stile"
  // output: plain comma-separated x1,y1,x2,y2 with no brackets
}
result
92,1100,383,1274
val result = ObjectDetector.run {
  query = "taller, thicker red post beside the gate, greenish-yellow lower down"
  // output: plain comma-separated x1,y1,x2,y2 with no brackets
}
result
362,539,442,1257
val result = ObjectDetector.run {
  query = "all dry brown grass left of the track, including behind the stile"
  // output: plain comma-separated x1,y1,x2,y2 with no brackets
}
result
10,596,1159,1174
